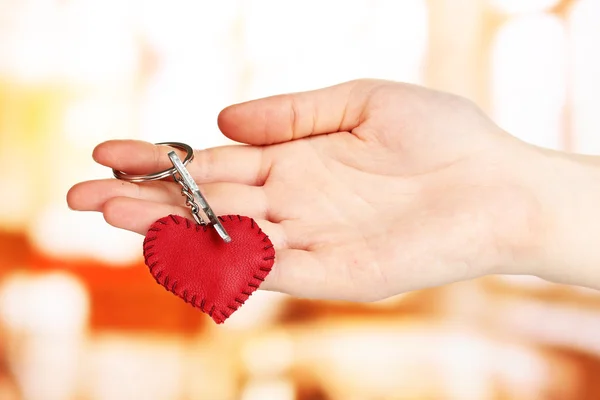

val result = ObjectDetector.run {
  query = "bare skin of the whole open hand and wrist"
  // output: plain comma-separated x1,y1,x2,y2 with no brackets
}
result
67,80,600,301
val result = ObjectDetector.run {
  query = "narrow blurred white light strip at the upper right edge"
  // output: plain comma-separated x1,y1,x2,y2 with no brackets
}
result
569,0,600,154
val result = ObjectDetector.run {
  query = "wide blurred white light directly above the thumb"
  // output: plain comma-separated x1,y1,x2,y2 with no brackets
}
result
243,0,427,98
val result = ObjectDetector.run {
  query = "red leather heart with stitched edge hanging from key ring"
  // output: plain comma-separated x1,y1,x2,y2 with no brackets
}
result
144,215,275,324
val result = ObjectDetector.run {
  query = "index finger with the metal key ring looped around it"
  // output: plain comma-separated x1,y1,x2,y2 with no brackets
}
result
92,140,270,185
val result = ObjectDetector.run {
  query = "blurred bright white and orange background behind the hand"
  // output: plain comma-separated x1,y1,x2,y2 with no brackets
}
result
0,0,600,400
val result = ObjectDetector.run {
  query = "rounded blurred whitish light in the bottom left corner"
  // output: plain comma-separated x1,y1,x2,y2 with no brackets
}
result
0,273,89,400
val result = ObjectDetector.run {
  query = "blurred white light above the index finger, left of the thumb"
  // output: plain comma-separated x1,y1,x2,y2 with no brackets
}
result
140,0,243,148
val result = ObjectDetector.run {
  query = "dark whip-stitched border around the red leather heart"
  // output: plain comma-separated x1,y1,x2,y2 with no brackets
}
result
143,214,275,324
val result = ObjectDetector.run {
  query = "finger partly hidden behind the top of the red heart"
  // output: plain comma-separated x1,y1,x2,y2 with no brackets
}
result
102,197,287,249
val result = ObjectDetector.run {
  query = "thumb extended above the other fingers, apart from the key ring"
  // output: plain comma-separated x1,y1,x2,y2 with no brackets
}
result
218,80,382,145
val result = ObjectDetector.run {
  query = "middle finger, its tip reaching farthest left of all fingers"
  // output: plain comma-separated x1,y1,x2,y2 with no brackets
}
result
67,179,267,218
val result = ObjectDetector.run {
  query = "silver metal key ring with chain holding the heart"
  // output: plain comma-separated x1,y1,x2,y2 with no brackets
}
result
113,142,231,243
